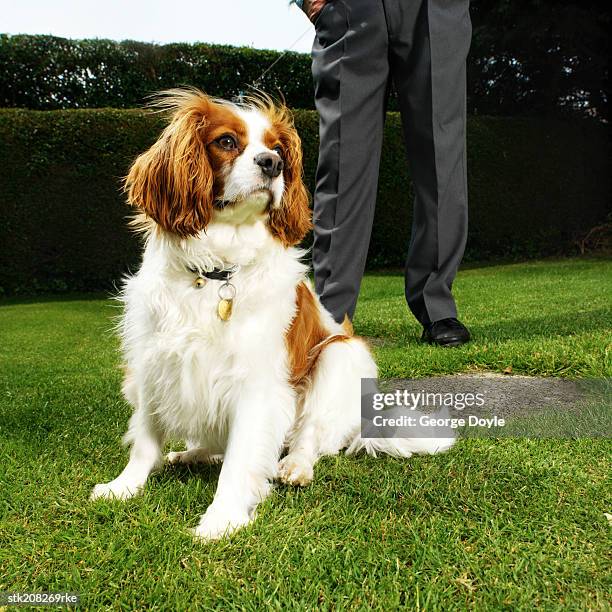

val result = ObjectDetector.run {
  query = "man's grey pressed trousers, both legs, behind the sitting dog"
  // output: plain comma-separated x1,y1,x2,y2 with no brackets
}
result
312,0,471,325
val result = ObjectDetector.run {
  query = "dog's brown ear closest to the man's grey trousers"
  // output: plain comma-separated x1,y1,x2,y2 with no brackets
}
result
268,107,312,246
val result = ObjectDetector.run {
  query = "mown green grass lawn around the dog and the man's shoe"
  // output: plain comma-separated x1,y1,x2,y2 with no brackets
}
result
0,260,612,611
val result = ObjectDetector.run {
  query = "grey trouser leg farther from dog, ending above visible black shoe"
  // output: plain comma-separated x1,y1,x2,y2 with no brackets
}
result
385,0,471,327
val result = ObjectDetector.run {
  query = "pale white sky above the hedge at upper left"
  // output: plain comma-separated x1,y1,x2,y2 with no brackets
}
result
0,0,314,52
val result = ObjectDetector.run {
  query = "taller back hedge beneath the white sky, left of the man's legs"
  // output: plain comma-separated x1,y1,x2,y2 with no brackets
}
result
0,35,314,110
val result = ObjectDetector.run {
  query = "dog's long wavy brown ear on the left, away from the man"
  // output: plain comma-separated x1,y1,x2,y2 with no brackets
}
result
125,93,214,237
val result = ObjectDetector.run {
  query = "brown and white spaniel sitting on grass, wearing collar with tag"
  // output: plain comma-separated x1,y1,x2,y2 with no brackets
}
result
91,89,451,540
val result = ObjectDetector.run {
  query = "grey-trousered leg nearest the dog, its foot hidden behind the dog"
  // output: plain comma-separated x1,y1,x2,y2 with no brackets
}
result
312,0,389,322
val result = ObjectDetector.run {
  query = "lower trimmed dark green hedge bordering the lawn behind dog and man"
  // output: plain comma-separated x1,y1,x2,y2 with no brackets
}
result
0,109,610,294
